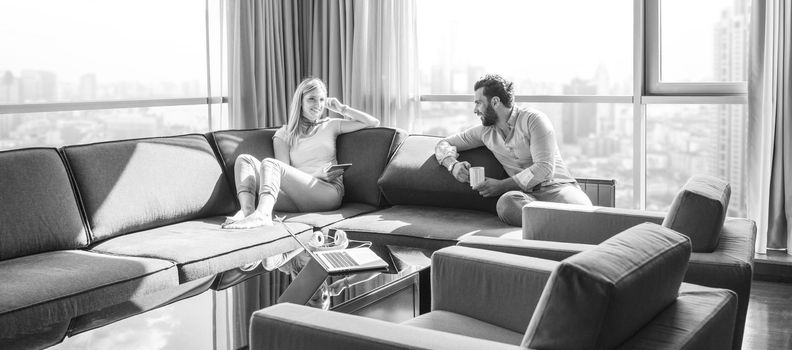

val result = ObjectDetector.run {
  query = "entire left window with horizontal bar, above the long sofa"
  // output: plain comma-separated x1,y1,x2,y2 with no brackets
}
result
0,0,225,149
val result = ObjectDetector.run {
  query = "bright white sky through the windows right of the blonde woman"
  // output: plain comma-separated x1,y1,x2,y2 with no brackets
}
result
418,0,734,82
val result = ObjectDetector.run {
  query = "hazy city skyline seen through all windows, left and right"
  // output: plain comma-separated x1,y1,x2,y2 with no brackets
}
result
0,0,747,216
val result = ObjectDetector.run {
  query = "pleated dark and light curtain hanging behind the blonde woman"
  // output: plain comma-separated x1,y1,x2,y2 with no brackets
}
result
228,0,419,129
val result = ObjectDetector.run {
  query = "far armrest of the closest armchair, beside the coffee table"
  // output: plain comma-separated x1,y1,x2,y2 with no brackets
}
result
431,246,558,333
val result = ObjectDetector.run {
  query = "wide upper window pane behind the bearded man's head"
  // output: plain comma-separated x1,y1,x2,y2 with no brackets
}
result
418,0,632,95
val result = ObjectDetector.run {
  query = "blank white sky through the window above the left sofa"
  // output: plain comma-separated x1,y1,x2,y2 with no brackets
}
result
0,0,206,81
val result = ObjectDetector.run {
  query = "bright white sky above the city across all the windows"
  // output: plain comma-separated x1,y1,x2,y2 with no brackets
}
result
0,0,734,86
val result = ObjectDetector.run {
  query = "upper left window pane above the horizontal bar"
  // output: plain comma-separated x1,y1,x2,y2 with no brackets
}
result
0,0,207,103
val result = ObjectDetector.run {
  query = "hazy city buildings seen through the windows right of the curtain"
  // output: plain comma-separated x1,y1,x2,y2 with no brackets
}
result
414,0,747,216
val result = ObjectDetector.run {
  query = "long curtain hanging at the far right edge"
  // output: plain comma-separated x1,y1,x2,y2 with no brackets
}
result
746,0,792,253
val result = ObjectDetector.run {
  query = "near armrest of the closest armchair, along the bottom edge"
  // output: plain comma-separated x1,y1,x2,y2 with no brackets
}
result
250,303,520,350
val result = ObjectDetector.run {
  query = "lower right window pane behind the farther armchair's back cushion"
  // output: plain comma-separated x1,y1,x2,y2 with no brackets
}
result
646,104,747,216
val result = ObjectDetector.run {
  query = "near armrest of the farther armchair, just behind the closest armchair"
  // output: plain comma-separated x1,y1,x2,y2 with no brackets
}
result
457,236,595,261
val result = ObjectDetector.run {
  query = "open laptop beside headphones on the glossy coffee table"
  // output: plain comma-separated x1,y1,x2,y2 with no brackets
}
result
281,222,388,274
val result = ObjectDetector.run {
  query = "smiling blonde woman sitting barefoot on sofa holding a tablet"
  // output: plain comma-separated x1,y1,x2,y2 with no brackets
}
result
222,78,379,229
